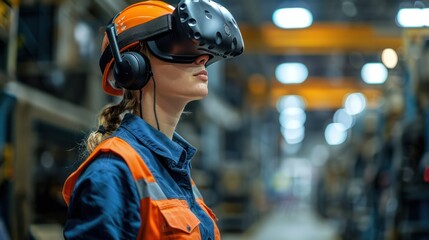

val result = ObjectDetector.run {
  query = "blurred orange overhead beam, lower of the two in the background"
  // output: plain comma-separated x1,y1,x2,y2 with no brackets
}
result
247,74,383,110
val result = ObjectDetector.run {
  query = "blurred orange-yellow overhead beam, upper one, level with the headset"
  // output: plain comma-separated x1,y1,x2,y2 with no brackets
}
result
240,23,403,54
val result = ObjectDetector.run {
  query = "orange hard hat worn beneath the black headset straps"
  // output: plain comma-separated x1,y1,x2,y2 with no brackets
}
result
101,1,175,96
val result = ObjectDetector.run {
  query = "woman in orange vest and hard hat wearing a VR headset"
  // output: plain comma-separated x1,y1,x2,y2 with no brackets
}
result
63,0,243,239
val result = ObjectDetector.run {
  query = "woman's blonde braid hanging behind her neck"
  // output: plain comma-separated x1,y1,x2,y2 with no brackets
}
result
85,90,140,154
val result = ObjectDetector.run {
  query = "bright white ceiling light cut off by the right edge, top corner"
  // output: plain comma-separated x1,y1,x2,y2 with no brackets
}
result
396,8,429,28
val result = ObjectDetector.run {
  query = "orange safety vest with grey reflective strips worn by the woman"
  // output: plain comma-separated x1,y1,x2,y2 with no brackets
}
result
63,137,220,240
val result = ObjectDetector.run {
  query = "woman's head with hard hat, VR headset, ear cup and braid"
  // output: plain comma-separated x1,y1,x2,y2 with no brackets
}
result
86,0,244,152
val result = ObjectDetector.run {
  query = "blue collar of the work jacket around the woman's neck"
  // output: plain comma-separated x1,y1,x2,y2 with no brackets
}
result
121,113,196,164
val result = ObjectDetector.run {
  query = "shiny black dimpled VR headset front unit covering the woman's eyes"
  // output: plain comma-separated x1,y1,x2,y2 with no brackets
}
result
148,0,244,65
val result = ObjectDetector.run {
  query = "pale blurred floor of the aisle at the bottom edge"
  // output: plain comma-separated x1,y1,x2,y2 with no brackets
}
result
222,204,339,240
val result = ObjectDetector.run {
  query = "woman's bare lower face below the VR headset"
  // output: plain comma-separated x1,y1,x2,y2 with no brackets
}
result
149,55,209,102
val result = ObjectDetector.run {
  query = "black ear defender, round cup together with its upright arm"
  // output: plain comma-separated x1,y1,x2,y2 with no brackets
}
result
106,23,151,90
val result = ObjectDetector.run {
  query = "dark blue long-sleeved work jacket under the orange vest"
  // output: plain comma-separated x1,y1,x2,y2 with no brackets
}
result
64,114,215,240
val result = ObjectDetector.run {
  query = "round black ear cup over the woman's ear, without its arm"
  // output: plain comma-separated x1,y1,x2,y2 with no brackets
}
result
113,51,151,90
